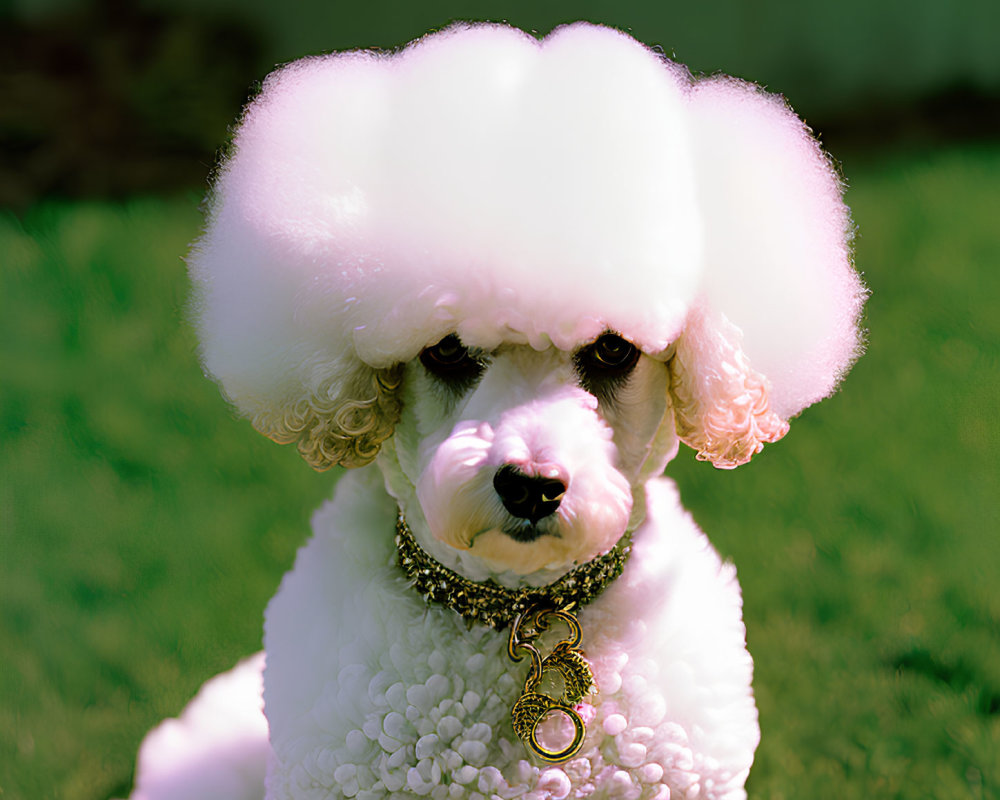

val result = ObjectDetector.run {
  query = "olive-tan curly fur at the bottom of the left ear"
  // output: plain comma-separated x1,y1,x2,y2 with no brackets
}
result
252,364,403,471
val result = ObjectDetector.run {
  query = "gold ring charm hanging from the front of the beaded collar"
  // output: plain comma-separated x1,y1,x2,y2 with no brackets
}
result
507,606,597,764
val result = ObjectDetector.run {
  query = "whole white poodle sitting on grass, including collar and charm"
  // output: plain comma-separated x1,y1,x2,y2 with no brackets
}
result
133,24,864,800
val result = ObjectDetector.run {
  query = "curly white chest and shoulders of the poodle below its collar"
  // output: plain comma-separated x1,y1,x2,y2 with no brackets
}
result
265,471,756,798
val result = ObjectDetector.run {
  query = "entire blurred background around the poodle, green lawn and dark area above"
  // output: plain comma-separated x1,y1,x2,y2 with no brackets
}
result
0,0,1000,800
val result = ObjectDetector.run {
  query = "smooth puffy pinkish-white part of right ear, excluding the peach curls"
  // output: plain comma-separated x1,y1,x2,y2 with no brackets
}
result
691,77,867,427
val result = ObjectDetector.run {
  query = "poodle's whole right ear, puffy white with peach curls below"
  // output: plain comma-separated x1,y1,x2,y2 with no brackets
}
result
671,78,866,468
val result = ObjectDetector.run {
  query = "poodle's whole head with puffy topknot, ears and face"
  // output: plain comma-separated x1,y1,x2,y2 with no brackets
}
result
190,24,865,577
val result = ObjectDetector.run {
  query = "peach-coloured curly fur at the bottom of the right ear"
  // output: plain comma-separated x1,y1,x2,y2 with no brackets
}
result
670,311,788,469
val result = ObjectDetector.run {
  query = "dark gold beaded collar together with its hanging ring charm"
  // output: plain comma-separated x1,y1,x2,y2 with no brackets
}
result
396,512,632,764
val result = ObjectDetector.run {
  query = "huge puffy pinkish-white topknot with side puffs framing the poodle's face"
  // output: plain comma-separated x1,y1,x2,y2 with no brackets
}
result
190,23,864,467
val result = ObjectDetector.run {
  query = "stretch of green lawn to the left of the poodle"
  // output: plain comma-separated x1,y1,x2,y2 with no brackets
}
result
0,195,332,800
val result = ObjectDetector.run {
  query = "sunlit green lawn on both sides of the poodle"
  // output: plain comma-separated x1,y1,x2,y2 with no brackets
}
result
0,148,1000,800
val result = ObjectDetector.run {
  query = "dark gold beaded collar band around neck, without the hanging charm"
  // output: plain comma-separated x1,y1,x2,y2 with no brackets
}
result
396,513,632,630
